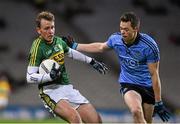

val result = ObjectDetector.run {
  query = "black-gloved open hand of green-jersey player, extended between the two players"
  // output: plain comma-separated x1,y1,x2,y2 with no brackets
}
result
90,59,108,74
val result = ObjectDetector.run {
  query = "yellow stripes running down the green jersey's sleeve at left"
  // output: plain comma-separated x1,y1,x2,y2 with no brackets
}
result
30,38,41,65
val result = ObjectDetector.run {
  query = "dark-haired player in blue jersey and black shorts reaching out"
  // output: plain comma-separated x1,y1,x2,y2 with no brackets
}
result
64,12,170,123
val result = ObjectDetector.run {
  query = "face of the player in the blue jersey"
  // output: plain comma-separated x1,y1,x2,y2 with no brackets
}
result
120,21,138,44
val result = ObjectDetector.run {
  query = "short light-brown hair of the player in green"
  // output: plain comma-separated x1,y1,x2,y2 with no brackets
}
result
36,11,55,27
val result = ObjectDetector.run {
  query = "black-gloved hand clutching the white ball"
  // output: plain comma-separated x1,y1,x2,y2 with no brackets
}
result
50,63,61,80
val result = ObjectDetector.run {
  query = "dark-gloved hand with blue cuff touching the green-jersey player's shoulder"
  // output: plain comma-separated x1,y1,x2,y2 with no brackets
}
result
62,35,78,50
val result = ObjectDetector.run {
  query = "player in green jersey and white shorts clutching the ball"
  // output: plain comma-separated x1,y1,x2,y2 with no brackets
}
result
26,11,107,123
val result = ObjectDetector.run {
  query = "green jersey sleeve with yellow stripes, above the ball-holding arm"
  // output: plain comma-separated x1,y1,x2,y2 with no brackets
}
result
28,39,42,66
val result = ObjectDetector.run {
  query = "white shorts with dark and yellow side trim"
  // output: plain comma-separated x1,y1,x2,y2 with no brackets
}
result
40,84,89,111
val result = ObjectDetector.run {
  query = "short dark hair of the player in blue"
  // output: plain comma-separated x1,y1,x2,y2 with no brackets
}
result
120,12,140,28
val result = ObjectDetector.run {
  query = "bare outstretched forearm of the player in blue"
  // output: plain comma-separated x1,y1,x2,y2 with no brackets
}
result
77,43,103,53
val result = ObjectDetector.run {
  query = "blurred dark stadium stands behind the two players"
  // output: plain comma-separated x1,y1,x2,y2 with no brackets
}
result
0,0,180,122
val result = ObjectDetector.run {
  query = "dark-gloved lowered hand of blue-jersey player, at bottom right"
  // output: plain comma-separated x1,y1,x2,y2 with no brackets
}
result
154,101,170,122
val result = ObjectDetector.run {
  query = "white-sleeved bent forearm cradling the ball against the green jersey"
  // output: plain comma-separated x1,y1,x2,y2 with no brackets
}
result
26,66,52,83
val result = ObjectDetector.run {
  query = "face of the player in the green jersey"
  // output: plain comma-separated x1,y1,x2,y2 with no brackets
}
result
37,19,55,43
